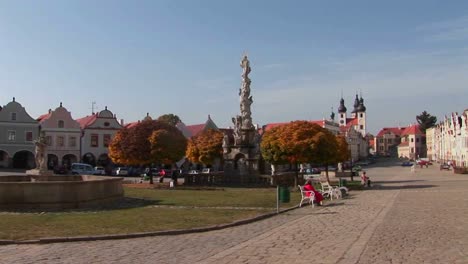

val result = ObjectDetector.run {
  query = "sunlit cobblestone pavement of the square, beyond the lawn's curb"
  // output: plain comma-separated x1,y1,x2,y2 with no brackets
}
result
0,162,468,263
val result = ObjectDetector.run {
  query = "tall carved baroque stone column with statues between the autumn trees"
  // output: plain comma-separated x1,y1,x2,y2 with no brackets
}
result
223,55,260,184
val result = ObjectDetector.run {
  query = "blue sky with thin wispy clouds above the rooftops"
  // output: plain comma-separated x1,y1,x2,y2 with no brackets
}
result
0,0,468,133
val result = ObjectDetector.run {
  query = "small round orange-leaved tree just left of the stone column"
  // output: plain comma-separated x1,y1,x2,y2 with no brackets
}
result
185,129,224,165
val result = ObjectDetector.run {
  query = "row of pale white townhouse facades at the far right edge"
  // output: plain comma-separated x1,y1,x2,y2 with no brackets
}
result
426,109,468,168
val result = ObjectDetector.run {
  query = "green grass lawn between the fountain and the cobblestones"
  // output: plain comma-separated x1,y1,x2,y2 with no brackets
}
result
0,188,300,240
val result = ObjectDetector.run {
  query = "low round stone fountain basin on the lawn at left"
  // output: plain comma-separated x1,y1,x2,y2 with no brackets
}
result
0,175,124,209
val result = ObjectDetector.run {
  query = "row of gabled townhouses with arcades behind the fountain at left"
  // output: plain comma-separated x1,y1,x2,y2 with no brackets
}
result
0,98,122,169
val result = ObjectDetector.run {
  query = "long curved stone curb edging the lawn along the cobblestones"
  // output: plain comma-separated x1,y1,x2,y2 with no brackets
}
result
0,206,299,245
